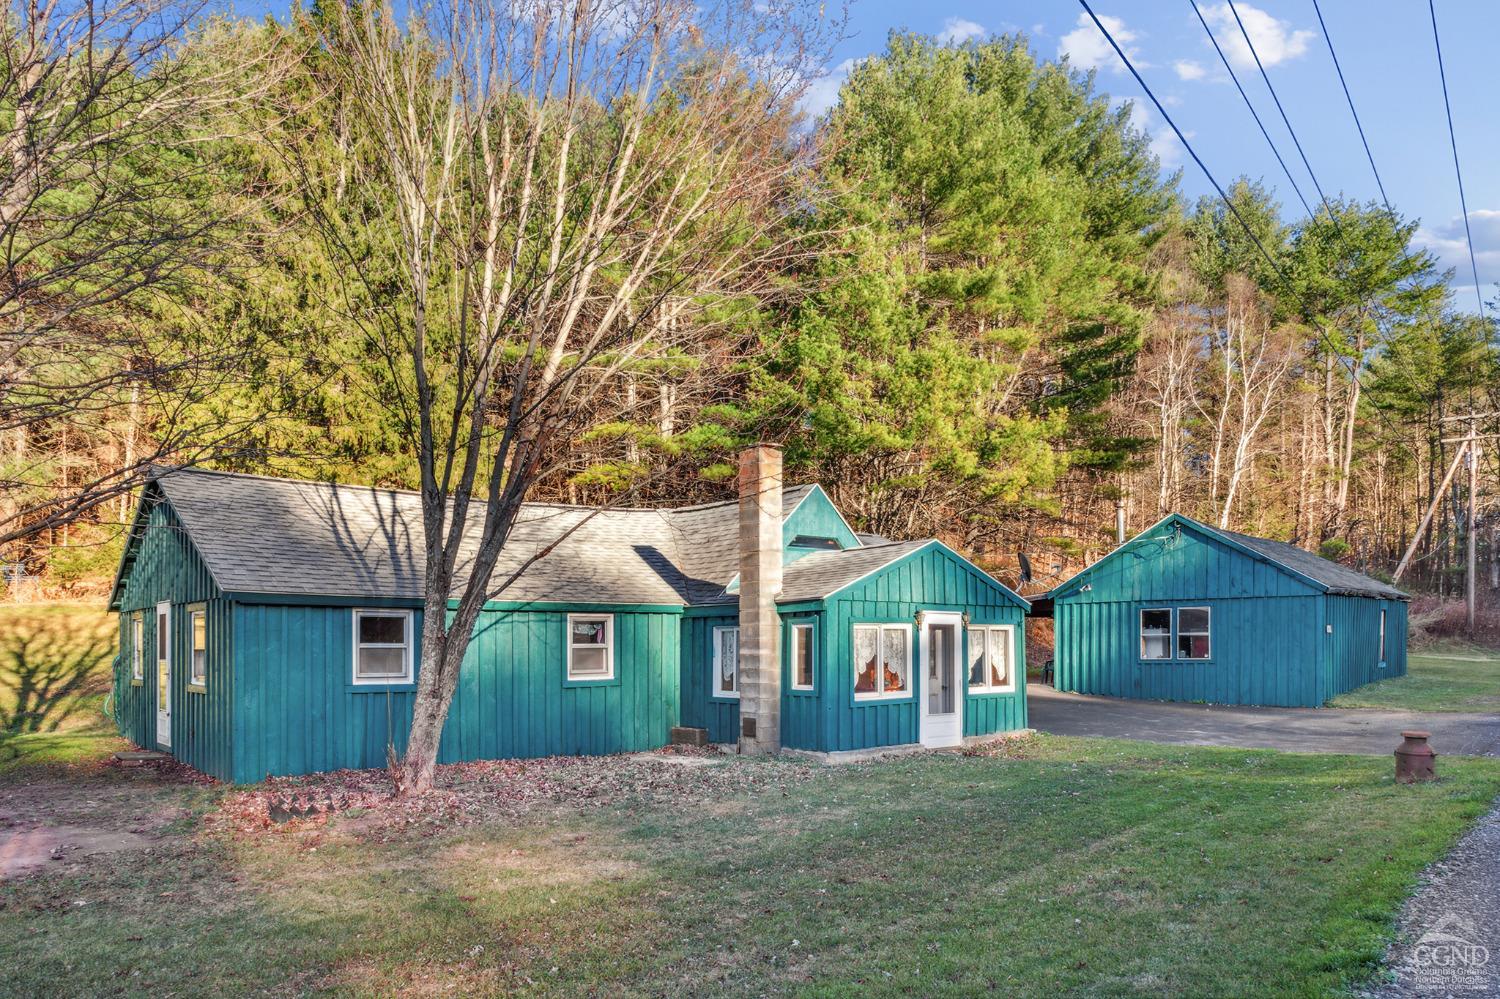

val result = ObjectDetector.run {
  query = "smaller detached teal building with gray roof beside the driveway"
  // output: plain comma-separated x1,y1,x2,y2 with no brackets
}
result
1049,515,1409,708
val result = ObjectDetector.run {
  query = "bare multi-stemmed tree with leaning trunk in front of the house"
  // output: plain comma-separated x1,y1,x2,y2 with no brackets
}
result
288,0,842,794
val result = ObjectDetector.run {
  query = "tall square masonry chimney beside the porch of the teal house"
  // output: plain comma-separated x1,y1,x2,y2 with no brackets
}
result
740,444,782,753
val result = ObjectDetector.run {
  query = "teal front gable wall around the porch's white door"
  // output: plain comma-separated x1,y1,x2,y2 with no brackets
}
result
807,548,1026,752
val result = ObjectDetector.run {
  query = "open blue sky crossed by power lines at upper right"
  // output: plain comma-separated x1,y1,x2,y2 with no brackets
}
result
809,0,1500,311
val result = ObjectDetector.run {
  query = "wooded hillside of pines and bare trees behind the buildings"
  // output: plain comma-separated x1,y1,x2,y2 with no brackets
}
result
0,11,1500,591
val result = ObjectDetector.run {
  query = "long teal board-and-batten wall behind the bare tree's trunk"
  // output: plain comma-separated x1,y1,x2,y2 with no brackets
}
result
236,594,680,782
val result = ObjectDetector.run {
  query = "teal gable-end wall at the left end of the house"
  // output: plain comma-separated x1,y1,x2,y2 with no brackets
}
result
114,503,234,780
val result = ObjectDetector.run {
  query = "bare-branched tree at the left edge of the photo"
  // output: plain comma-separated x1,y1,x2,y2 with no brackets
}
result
0,0,287,543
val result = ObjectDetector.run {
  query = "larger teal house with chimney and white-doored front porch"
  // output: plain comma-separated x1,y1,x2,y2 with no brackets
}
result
110,447,1028,783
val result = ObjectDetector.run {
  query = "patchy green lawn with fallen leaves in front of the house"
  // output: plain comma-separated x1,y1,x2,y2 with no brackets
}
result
0,737,1500,996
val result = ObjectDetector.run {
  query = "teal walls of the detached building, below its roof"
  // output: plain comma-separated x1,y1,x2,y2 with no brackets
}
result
1053,527,1406,708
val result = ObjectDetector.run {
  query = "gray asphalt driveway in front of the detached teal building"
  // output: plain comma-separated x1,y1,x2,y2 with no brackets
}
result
1026,683,1500,756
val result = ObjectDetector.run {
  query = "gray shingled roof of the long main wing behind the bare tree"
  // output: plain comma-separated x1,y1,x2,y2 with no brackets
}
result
132,470,857,605
